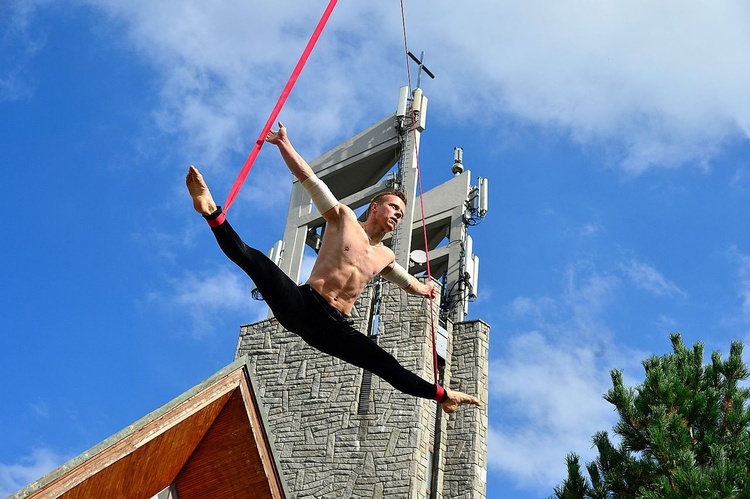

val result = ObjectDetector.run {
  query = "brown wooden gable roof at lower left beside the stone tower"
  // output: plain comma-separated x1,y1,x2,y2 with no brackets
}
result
11,358,288,499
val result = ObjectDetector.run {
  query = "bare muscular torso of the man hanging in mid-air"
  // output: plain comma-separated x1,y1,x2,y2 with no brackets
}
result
307,205,394,315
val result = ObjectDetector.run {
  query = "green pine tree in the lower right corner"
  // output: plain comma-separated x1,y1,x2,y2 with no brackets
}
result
552,334,750,499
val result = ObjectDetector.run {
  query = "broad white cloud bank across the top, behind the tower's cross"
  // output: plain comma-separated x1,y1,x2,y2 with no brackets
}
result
10,0,750,173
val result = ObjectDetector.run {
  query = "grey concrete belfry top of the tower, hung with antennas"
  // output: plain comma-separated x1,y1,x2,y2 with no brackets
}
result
271,89,487,322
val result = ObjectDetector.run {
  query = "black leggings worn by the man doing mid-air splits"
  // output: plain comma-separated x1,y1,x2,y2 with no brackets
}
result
211,220,442,399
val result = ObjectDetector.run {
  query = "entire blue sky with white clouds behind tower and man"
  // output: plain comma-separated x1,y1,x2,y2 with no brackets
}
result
0,0,750,498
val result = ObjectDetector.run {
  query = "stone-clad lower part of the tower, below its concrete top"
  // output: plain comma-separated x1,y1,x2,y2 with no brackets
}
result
237,284,489,499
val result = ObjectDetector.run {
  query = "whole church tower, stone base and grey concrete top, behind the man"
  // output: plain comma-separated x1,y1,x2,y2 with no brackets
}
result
236,88,489,499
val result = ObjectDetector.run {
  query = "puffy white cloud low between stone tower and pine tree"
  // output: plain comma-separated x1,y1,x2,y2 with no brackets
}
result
489,332,614,491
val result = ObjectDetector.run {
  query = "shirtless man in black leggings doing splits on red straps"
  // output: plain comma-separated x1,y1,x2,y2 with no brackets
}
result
186,122,480,413
